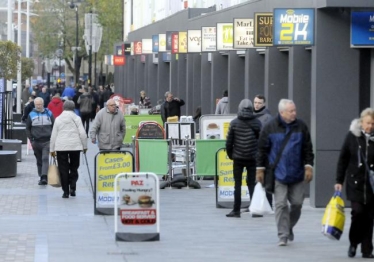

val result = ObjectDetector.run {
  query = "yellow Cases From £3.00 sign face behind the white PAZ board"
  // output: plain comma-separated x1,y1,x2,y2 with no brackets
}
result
96,152,133,193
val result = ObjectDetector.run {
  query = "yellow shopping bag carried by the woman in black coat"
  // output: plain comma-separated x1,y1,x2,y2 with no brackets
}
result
322,191,345,240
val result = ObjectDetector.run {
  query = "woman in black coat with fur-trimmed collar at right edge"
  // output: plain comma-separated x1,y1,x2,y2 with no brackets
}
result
335,108,374,258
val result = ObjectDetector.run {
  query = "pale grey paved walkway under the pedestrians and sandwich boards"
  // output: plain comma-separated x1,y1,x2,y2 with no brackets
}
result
0,139,362,262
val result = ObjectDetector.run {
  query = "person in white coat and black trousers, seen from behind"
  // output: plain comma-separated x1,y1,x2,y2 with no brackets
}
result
50,100,87,198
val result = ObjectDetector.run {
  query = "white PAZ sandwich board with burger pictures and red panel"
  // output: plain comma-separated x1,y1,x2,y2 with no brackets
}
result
114,172,160,242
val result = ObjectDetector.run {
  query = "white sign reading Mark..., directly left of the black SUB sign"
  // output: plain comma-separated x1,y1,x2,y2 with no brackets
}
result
234,18,254,49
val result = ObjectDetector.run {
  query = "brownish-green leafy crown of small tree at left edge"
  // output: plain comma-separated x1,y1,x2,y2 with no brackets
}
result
0,41,21,80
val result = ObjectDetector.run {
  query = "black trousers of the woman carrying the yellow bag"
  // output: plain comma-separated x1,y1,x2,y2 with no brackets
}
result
349,199,374,254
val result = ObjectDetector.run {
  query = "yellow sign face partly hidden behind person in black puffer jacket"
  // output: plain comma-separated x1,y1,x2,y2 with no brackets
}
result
217,149,249,201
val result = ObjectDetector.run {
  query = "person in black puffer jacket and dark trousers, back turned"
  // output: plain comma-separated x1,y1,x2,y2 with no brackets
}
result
226,99,261,217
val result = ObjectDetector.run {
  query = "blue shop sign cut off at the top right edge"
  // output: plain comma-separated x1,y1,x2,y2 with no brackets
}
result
351,12,374,47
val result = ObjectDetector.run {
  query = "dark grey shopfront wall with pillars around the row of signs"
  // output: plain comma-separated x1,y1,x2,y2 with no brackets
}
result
115,0,374,207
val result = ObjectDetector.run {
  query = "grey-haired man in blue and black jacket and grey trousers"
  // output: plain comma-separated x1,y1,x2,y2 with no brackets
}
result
256,99,314,246
